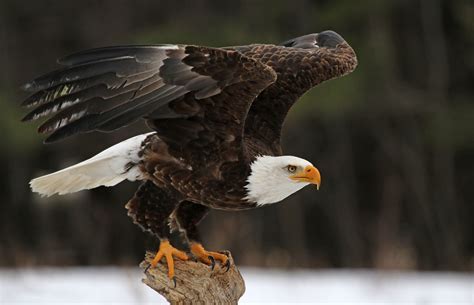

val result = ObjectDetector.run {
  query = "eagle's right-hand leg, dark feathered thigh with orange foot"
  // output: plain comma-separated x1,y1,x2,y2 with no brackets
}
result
175,201,230,270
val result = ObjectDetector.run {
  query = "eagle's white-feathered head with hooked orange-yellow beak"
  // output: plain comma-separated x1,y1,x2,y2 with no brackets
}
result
245,156,321,206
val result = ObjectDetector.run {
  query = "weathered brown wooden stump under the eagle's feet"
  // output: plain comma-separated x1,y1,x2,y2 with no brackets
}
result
140,251,245,304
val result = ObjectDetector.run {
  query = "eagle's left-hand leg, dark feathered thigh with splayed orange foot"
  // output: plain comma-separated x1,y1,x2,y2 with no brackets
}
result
125,181,188,283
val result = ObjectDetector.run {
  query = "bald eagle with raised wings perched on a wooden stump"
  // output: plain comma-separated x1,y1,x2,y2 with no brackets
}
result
23,31,357,279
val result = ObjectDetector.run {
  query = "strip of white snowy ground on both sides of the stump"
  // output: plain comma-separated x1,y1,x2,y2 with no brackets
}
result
0,268,474,305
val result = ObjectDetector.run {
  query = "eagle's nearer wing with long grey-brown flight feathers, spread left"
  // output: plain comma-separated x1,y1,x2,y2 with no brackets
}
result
23,45,276,165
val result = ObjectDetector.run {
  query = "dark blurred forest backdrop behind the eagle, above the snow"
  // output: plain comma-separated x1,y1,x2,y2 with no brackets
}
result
0,0,474,271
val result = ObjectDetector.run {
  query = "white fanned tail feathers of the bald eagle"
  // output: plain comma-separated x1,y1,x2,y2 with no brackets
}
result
30,133,150,196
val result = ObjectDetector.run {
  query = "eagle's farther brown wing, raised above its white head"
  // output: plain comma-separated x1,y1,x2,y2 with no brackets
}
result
236,31,357,154
